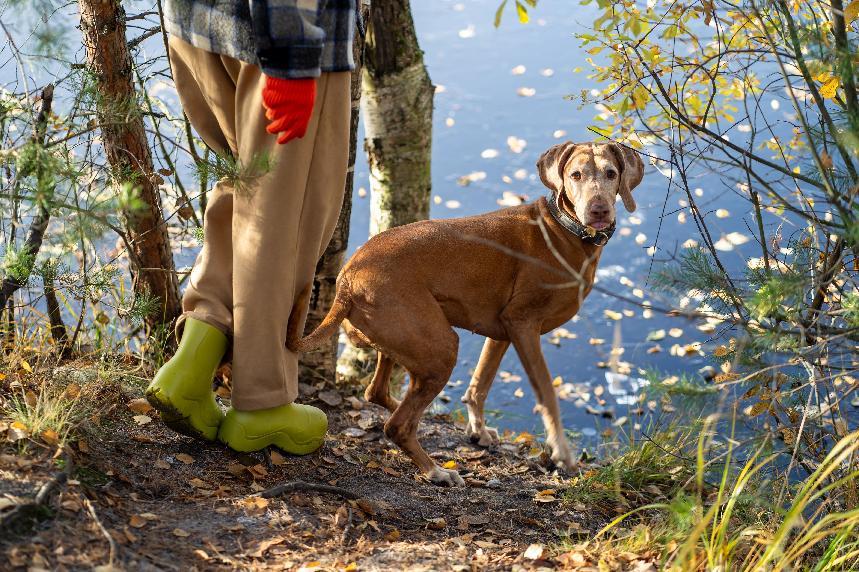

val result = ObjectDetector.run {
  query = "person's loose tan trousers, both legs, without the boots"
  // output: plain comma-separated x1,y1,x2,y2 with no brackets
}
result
169,37,351,410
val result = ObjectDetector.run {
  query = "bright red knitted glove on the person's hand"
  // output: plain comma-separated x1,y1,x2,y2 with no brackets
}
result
262,76,316,144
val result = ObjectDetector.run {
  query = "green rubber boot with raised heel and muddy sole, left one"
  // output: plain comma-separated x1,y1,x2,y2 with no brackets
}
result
146,318,227,441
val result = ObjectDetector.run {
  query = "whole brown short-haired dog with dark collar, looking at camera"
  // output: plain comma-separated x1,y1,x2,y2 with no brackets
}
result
287,142,644,485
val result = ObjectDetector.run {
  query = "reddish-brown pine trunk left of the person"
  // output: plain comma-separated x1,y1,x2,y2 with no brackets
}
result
79,0,181,330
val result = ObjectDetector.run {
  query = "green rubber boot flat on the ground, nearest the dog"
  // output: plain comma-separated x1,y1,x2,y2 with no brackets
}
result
218,403,328,455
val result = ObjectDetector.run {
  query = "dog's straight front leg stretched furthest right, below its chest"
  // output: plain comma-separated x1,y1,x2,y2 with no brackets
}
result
505,321,576,471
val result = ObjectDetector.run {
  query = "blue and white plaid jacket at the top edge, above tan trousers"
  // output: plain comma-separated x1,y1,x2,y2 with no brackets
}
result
164,0,362,78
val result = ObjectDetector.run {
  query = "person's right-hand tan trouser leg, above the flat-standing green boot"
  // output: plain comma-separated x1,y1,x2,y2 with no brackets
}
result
232,66,350,411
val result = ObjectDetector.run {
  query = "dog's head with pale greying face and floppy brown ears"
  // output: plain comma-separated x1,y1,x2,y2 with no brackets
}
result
537,141,644,230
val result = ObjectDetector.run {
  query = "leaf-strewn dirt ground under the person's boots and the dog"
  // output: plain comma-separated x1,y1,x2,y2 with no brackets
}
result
0,364,605,571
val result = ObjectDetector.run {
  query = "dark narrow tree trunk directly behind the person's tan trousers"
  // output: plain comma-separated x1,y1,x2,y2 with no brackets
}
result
299,0,372,381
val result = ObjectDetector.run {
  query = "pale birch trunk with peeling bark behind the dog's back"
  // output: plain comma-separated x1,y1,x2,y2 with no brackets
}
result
337,0,435,382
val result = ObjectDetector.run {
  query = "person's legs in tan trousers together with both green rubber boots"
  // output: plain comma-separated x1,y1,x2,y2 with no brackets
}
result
147,38,350,453
